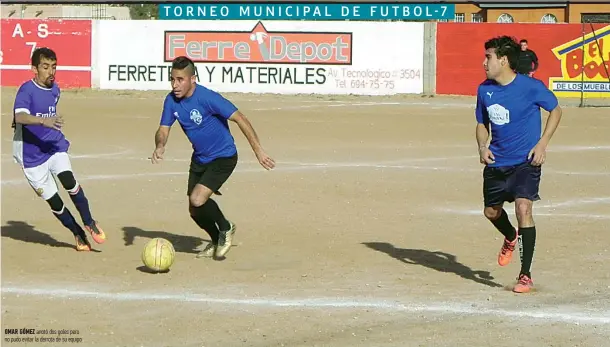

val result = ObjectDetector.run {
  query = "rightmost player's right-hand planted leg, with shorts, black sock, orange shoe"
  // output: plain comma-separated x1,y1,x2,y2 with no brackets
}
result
513,163,542,293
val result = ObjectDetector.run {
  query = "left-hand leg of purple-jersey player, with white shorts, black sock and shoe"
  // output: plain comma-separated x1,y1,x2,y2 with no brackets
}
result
23,162,91,251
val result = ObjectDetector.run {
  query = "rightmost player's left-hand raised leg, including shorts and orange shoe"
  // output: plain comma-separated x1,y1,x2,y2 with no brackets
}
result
483,167,517,266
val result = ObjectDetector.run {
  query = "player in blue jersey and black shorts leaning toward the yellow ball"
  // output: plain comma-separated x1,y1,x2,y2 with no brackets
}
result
151,57,275,258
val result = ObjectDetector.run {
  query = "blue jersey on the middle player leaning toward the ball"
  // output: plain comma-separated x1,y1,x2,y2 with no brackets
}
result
161,84,237,164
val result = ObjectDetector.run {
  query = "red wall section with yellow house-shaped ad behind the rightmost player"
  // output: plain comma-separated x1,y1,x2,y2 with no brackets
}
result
436,23,610,98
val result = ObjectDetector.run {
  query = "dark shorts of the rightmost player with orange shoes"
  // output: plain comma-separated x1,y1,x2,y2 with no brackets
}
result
483,162,542,207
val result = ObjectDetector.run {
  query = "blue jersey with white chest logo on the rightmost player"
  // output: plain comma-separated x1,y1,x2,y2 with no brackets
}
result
475,74,558,167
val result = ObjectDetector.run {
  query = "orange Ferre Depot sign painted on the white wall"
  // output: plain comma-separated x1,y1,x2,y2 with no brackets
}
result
164,22,352,65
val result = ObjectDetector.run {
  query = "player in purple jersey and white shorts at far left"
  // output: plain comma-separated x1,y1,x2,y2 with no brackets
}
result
13,48,106,251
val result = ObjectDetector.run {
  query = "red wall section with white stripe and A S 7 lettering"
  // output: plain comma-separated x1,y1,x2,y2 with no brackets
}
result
0,19,92,89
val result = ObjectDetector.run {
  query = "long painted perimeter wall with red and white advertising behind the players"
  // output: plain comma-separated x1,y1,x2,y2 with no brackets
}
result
0,20,610,97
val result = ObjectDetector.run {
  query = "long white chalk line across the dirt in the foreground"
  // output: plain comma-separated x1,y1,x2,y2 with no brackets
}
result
2,287,610,325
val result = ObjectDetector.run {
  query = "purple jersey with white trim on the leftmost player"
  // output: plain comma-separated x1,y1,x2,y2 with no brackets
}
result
13,80,70,168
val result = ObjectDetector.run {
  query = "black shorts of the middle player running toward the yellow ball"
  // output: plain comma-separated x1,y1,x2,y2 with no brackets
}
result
186,154,237,195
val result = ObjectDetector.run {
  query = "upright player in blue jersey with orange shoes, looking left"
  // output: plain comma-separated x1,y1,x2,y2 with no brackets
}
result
475,36,562,293
